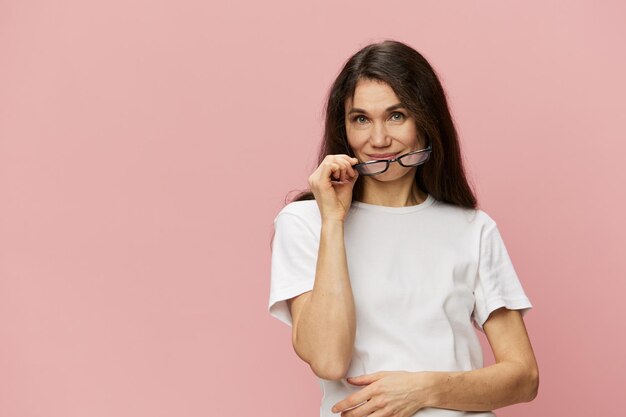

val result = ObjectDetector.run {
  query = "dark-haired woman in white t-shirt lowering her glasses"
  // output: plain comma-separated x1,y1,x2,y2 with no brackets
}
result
269,41,538,417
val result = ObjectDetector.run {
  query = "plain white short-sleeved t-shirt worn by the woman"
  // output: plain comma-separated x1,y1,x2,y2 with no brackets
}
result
269,195,532,417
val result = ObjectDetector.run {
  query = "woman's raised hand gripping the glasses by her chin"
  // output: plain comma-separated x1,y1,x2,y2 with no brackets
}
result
309,154,359,221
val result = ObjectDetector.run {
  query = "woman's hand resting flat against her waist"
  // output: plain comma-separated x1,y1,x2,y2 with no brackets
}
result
332,371,432,417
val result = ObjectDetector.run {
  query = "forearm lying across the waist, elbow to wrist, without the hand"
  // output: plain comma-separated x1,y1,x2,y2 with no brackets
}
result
427,362,538,411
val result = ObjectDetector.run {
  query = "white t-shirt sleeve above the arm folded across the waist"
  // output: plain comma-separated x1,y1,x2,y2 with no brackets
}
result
473,221,532,331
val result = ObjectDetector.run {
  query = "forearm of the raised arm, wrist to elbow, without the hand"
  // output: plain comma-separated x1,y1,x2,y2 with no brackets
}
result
295,221,356,379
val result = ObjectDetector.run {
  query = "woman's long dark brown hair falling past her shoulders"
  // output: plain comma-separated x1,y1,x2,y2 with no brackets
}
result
291,40,477,209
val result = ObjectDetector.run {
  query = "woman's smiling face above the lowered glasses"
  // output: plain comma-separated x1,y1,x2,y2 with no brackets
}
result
345,79,425,181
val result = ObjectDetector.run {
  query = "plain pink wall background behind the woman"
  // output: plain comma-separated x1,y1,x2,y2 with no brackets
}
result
0,0,626,417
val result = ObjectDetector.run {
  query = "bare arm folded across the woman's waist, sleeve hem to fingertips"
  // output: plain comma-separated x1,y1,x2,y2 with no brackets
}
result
332,308,539,417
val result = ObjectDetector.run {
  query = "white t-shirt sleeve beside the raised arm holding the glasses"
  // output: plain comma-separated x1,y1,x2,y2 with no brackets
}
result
268,212,319,326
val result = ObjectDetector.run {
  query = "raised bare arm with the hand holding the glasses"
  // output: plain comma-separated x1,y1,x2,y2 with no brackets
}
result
288,154,358,380
